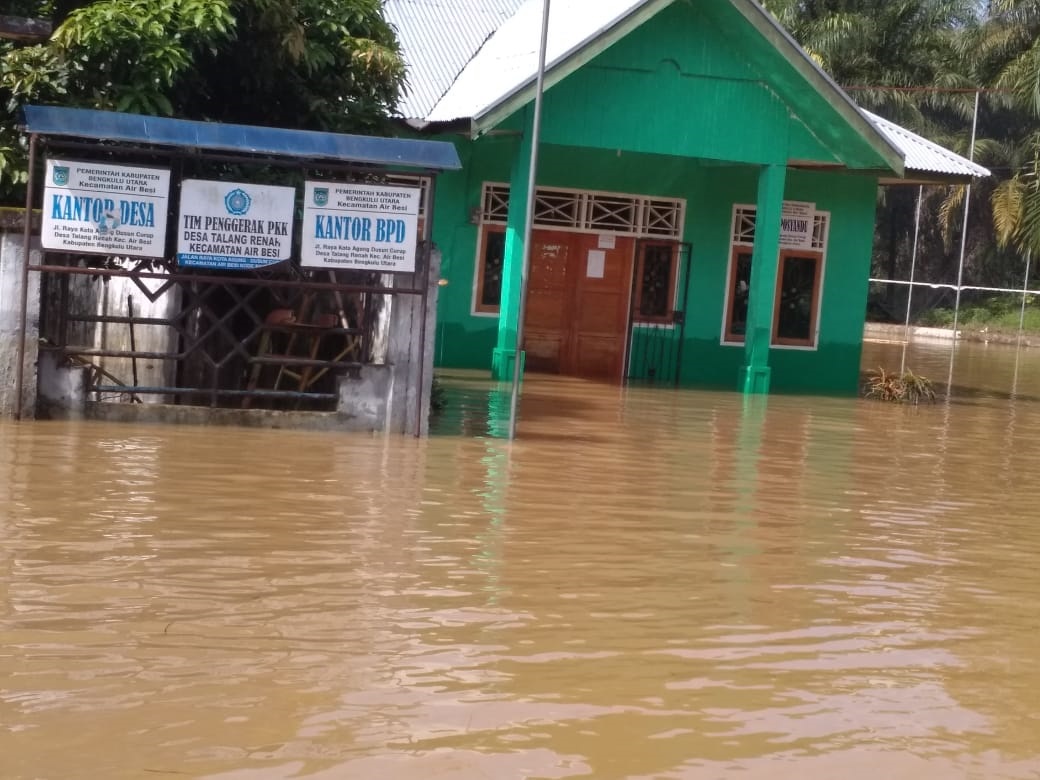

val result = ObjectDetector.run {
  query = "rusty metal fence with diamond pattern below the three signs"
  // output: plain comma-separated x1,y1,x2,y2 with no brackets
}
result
33,257,425,411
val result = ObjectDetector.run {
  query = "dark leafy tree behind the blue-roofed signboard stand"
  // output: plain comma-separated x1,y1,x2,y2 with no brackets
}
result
0,0,405,202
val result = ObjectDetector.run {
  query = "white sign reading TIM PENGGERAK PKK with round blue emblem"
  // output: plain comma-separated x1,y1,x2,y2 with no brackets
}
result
177,179,296,270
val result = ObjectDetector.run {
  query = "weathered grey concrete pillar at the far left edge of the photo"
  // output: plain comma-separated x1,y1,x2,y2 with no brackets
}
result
0,217,40,419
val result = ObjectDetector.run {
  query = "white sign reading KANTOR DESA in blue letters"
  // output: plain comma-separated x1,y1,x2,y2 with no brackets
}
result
41,159,170,257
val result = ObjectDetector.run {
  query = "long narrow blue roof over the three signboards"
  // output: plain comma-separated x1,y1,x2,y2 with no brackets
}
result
22,106,462,171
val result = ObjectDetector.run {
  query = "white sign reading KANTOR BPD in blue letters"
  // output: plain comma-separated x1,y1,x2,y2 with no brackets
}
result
300,181,419,272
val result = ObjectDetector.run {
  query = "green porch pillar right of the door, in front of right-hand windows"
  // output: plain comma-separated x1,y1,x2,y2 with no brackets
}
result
744,165,787,394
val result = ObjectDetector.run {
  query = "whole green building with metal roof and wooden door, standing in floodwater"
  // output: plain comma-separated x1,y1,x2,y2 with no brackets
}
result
386,0,988,394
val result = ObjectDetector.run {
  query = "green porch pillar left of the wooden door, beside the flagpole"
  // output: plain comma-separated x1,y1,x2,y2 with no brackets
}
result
491,112,532,382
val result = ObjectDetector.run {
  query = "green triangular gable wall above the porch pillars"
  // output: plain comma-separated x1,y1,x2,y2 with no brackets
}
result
511,2,891,172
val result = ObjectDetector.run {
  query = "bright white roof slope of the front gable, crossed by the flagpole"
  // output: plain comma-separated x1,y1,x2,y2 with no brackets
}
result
426,0,648,122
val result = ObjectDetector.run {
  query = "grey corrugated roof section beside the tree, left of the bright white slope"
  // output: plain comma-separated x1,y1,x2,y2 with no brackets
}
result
384,0,524,120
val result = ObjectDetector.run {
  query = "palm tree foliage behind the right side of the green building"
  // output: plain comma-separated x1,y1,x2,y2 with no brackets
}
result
765,0,1040,307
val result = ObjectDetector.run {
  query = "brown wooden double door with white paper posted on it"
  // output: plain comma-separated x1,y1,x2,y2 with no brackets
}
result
523,230,635,382
